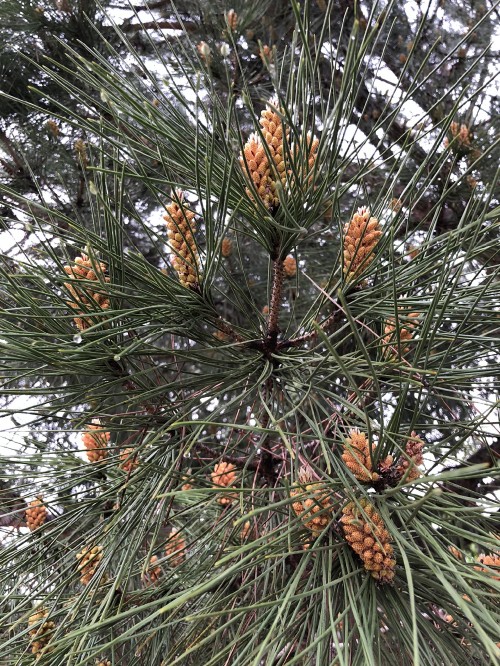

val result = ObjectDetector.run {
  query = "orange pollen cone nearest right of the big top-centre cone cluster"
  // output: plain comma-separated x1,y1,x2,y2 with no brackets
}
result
344,208,382,282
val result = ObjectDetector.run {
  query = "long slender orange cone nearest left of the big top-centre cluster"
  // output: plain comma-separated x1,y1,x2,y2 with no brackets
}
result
163,192,200,288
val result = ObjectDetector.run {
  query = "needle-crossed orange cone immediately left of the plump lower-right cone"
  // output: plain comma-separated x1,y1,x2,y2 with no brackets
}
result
290,467,333,537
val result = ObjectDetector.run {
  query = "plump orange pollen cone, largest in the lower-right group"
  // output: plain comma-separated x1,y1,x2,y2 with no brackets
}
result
340,499,396,583
